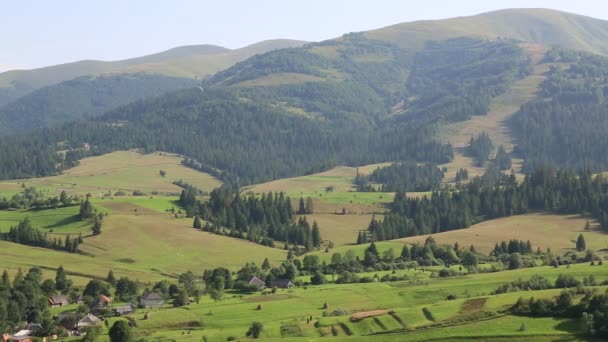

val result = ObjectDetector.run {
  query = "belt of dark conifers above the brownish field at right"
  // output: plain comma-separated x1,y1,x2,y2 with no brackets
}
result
365,166,608,241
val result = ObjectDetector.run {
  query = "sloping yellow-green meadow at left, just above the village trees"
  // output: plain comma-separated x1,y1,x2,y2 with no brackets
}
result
0,197,285,282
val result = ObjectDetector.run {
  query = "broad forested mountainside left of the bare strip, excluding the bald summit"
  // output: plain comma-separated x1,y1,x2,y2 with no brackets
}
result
2,34,529,185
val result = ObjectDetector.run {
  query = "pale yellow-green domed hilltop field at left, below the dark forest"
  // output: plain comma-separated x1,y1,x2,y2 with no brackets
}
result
0,151,221,197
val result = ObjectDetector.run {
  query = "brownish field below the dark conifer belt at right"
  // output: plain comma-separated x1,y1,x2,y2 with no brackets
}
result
397,214,608,253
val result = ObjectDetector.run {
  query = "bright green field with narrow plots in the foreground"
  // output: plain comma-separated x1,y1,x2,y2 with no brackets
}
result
50,265,608,341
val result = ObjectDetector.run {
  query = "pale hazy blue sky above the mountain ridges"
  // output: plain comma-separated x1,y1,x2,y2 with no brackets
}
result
0,0,608,71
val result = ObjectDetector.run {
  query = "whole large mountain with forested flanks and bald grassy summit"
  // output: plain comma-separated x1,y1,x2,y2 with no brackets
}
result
0,10,608,185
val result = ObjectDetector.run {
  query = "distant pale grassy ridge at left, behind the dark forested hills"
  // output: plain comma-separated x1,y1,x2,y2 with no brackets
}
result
0,39,304,105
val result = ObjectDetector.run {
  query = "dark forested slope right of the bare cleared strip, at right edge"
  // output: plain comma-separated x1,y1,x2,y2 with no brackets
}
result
512,49,608,171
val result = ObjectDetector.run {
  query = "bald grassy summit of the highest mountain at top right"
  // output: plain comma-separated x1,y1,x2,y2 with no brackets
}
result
365,9,608,55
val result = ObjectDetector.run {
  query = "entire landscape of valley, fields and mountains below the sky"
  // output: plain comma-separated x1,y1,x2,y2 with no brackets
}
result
0,9,608,342
